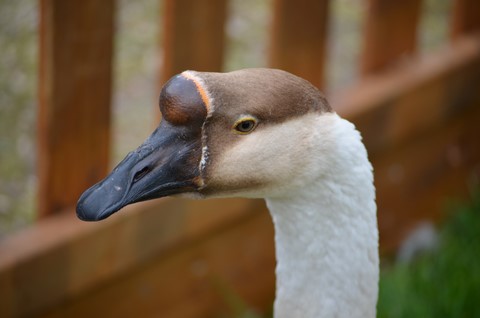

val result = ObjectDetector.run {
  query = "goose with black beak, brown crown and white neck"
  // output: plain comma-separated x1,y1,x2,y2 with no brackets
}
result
77,68,379,318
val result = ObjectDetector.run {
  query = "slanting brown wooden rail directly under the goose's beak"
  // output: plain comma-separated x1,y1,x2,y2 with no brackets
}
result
0,199,265,317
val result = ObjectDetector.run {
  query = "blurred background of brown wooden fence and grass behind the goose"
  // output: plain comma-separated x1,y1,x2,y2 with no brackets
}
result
0,0,480,317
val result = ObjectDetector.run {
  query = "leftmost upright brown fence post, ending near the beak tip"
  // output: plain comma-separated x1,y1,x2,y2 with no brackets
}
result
38,0,115,217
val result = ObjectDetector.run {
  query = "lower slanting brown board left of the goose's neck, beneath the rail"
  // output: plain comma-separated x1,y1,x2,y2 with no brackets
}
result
45,202,275,318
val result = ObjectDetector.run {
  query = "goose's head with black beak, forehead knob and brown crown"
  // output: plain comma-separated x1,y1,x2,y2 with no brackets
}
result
77,69,332,221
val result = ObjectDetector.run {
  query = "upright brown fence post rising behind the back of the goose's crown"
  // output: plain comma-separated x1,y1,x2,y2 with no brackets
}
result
270,0,329,87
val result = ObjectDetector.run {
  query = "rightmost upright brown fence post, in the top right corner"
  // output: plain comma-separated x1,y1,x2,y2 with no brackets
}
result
450,0,480,40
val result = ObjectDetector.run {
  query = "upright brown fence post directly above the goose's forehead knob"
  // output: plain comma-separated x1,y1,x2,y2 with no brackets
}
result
160,0,227,84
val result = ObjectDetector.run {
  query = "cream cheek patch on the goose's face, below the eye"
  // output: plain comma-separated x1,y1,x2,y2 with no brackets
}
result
206,113,330,196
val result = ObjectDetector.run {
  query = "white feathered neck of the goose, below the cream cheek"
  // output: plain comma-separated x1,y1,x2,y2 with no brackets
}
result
267,114,379,318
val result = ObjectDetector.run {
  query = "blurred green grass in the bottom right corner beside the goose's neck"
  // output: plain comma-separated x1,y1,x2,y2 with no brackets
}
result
378,193,480,318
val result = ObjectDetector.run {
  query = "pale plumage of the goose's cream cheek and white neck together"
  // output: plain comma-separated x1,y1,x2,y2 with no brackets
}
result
208,113,379,318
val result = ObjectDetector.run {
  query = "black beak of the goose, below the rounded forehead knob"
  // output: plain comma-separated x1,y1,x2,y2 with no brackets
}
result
77,121,201,221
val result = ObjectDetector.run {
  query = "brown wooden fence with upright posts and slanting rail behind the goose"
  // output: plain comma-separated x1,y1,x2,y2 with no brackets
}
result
0,0,480,317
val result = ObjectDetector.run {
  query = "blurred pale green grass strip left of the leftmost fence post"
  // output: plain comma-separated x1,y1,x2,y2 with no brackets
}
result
0,0,37,237
